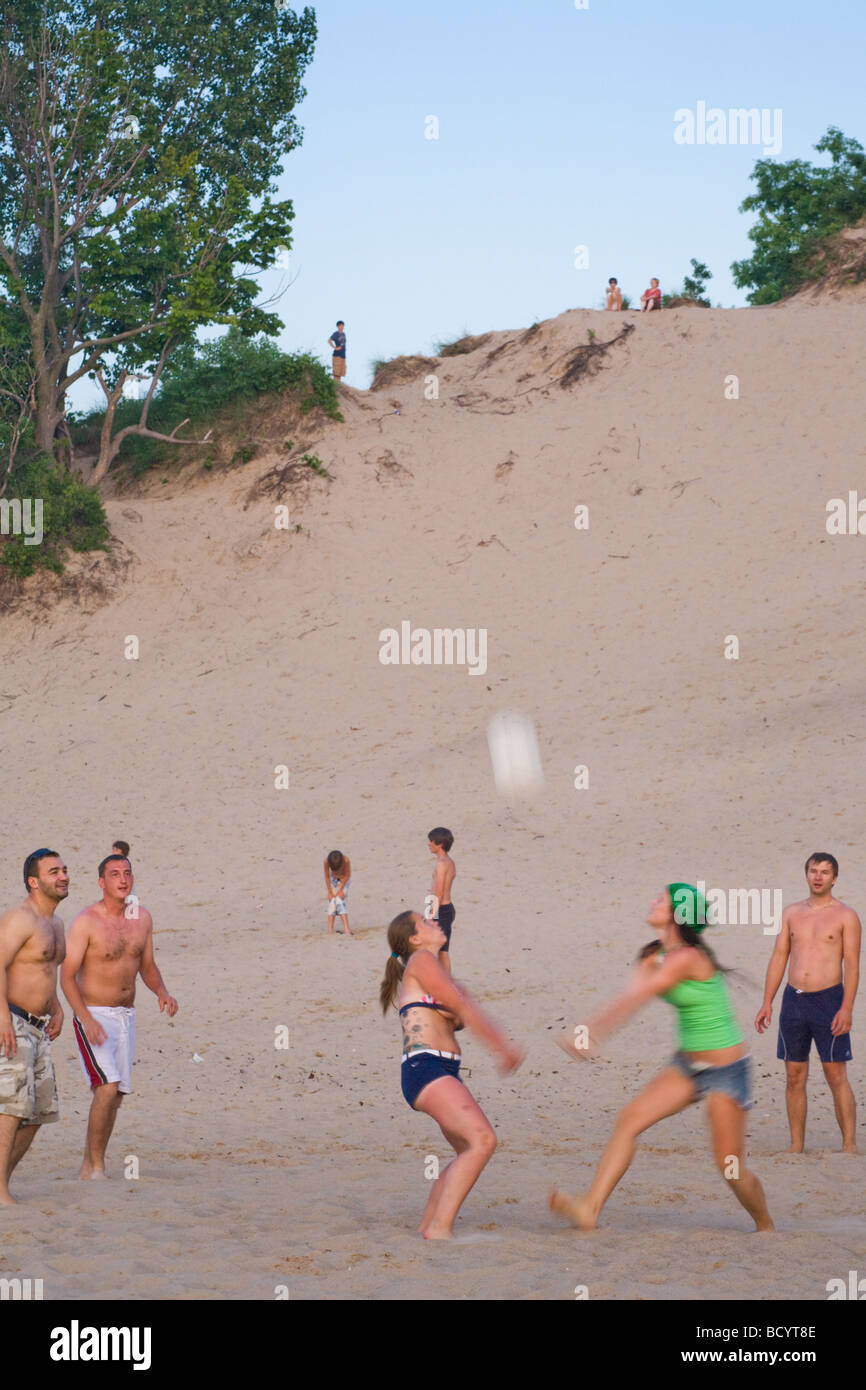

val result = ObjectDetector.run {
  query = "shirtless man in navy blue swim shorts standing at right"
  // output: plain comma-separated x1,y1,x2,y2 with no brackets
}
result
755,852,860,1154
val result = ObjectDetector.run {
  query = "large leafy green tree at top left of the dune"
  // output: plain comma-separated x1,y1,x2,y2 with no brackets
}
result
0,0,316,482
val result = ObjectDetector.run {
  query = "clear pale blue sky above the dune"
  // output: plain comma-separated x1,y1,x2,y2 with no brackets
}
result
74,0,866,403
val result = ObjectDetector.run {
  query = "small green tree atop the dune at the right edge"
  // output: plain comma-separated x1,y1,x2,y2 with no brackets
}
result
731,125,866,304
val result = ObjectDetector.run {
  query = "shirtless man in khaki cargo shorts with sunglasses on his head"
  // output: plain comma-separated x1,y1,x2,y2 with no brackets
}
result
0,849,70,1207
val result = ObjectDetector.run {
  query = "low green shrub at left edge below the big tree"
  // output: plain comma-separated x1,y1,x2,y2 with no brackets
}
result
0,455,110,578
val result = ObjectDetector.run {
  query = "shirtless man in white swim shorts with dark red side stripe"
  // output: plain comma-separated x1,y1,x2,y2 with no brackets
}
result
60,855,178,1179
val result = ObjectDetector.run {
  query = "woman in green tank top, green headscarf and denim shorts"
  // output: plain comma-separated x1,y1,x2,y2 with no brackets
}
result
549,883,773,1230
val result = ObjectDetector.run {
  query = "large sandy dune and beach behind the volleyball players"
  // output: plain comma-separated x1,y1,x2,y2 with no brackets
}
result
0,303,866,1300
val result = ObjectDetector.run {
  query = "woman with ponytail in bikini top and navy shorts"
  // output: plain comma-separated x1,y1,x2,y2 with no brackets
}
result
379,912,523,1240
